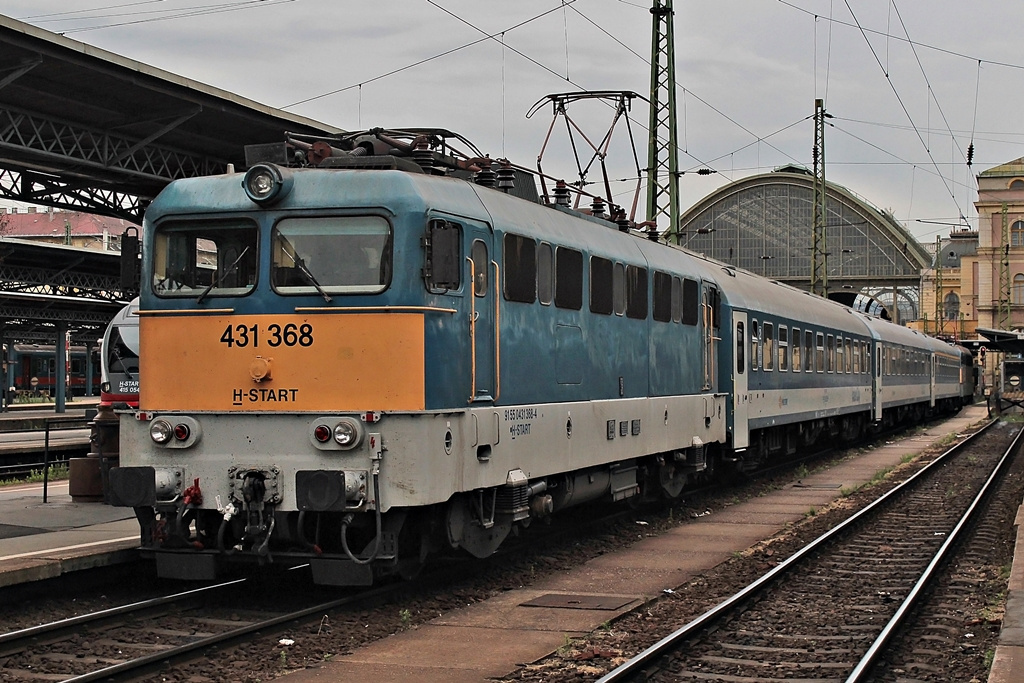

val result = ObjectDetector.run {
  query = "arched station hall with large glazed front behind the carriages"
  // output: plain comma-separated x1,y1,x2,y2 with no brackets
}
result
679,166,933,324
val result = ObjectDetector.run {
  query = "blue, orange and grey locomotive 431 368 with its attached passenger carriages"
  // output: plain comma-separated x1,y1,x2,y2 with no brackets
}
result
110,129,973,585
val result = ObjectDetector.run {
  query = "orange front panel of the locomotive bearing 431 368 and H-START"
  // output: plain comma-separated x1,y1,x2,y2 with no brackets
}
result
139,313,424,412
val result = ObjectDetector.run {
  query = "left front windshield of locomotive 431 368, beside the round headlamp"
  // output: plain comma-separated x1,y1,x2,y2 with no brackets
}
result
153,219,259,298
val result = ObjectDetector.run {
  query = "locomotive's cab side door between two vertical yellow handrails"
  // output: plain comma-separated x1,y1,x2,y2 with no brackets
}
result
466,225,498,403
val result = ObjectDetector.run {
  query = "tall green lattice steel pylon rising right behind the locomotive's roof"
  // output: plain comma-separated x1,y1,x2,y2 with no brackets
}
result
647,0,680,244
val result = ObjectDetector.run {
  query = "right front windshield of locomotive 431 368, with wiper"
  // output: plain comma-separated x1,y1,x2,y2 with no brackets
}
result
270,216,391,294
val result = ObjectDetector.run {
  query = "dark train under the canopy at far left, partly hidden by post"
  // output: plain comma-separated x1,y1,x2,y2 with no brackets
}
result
7,344,100,396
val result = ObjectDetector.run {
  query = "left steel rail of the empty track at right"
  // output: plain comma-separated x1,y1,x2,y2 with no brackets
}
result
596,420,998,683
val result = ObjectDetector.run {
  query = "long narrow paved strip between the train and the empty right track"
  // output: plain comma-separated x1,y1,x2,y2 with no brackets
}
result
284,405,987,683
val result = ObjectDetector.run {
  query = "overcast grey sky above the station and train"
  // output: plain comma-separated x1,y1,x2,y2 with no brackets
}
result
0,0,1024,243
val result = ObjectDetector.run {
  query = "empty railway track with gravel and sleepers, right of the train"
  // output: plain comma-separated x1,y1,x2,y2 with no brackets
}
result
599,422,1022,683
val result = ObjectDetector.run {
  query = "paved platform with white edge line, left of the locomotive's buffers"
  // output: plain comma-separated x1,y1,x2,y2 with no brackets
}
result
0,480,139,587
